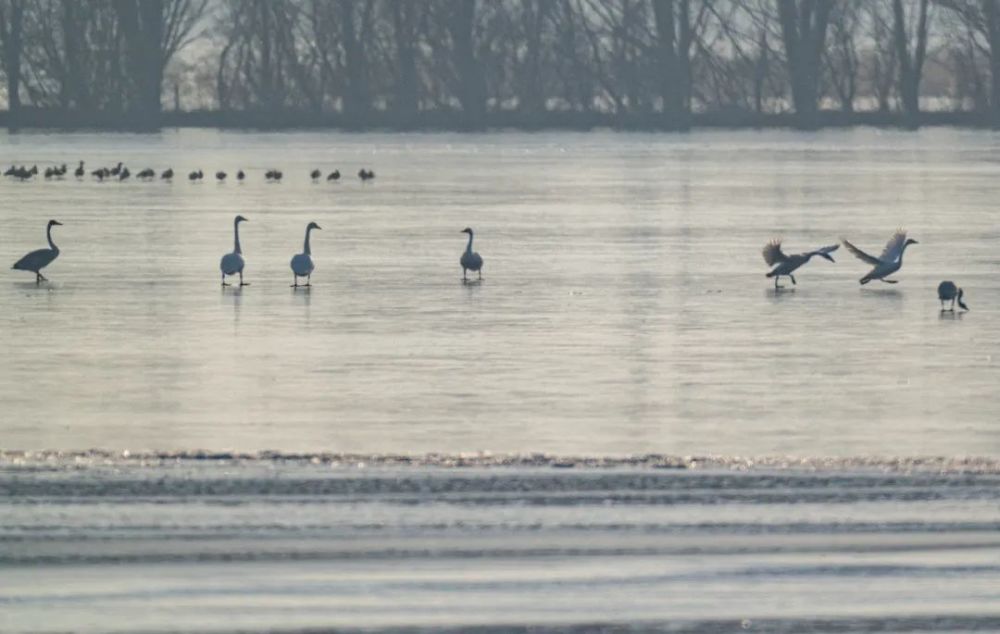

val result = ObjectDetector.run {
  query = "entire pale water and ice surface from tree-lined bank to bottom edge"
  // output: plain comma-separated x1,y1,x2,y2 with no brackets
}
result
0,130,1000,632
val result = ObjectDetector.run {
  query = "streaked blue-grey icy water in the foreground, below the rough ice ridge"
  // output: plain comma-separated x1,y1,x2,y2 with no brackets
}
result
0,454,1000,634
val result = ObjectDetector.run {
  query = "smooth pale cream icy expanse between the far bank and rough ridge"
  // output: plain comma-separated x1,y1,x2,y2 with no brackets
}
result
0,130,1000,456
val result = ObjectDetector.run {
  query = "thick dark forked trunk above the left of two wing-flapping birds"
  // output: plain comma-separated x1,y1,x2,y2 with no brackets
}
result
777,0,832,129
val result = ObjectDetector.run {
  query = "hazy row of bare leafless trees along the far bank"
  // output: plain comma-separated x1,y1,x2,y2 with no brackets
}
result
0,0,1000,129
